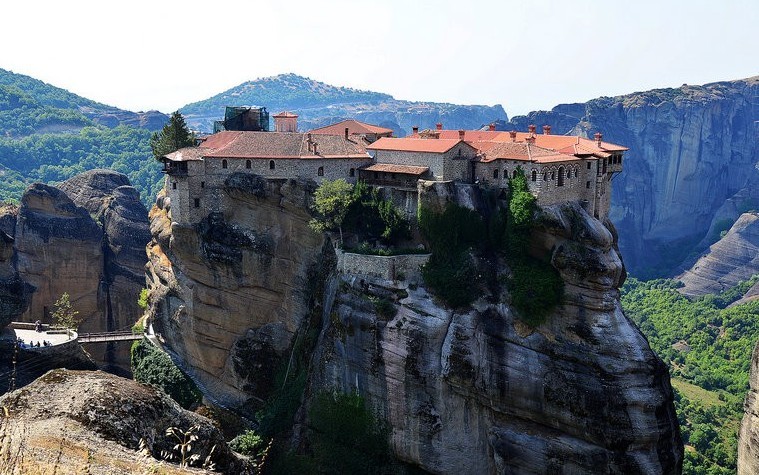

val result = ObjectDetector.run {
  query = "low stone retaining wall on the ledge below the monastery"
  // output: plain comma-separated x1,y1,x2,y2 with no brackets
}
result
335,249,430,280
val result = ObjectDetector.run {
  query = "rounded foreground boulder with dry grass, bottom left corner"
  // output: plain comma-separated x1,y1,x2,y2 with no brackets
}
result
0,369,252,474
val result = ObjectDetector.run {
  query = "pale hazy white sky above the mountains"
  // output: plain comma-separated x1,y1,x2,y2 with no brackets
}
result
0,0,759,116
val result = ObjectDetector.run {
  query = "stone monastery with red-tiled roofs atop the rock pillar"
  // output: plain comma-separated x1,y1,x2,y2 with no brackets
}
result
162,108,628,224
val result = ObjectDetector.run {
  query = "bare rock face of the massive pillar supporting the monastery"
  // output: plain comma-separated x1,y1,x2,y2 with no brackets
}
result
144,180,683,474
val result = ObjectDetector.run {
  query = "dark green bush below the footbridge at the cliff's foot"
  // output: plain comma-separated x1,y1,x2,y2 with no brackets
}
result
131,338,201,409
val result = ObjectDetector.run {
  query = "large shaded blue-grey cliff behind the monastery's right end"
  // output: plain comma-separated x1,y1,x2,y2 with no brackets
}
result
501,77,759,275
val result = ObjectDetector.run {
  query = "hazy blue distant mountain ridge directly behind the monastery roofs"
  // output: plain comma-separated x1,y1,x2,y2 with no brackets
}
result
180,73,508,136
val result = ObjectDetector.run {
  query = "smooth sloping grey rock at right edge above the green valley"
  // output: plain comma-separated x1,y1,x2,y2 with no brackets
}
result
678,213,759,296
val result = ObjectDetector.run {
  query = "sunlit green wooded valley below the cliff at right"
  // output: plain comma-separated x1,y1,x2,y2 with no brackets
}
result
622,276,759,475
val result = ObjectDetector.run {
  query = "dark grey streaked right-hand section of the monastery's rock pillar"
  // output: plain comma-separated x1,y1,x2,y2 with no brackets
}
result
314,192,683,473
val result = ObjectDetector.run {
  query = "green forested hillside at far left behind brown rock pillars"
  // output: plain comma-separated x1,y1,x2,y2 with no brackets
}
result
0,69,166,204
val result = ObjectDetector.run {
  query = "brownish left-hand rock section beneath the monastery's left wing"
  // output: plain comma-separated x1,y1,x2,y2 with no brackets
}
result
147,174,324,406
